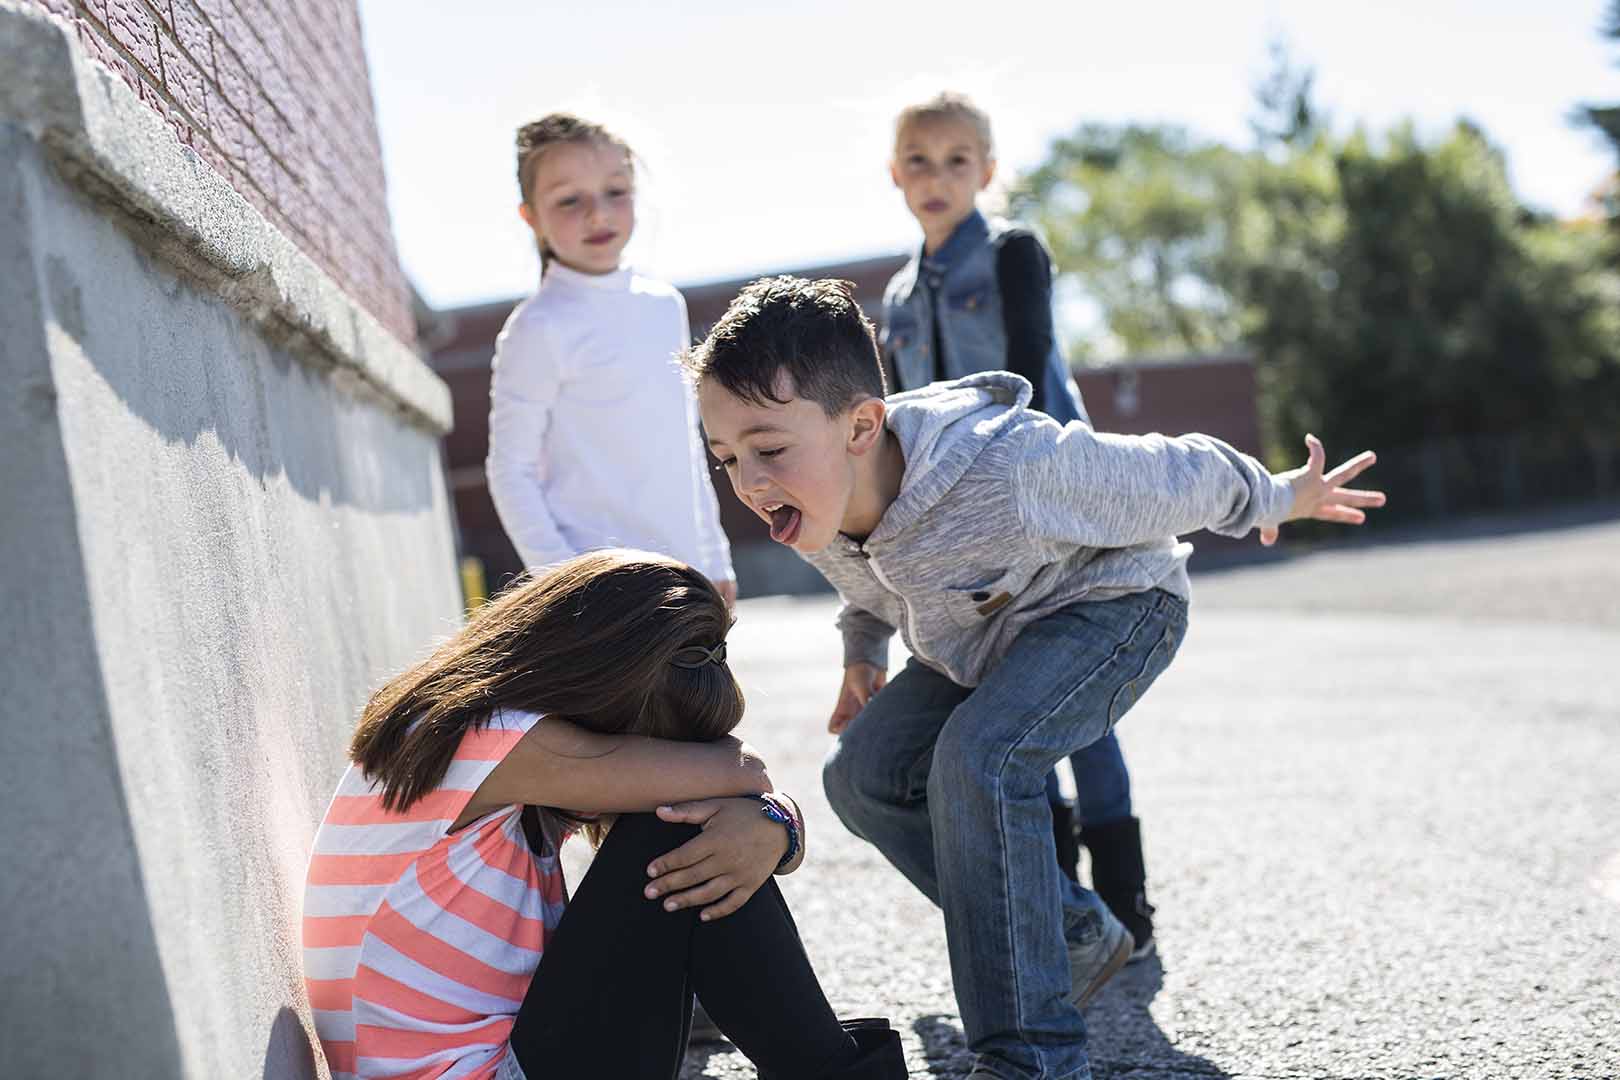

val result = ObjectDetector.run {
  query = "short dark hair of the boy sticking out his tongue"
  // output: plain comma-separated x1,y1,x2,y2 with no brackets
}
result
680,275,888,416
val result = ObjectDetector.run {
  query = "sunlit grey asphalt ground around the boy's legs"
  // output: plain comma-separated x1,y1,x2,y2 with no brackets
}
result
684,507,1620,1080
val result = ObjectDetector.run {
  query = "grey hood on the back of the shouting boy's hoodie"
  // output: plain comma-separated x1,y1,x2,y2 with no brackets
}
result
868,371,1034,542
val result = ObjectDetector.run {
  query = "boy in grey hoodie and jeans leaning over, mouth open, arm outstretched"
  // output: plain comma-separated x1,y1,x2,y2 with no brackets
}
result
685,277,1383,1080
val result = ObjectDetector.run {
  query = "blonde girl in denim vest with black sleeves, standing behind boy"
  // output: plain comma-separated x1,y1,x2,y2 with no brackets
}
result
881,92,1153,960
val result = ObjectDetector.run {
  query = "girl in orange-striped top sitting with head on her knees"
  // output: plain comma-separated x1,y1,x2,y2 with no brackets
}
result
303,551,906,1080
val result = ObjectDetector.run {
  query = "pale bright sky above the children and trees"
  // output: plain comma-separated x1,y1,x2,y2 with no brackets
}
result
360,0,1620,308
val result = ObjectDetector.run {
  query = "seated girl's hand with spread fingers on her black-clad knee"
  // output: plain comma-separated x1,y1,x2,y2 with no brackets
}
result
645,798,787,921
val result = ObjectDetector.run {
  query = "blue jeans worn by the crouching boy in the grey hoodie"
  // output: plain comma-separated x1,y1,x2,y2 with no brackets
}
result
823,589,1187,1080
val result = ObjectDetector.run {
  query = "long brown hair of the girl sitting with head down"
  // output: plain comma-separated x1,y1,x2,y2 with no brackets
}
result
348,549,744,810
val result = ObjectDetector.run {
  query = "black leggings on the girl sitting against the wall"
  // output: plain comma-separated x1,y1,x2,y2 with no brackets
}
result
512,814,857,1080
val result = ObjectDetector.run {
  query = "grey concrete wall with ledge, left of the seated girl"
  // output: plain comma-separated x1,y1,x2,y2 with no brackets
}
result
0,0,460,1078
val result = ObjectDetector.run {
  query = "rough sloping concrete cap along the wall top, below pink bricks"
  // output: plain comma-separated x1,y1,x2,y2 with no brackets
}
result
0,0,452,434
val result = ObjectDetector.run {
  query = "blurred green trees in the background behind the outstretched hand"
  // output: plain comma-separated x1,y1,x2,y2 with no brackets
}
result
1019,102,1620,495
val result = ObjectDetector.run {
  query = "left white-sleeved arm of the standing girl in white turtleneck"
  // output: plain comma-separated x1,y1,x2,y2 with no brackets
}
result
484,321,575,568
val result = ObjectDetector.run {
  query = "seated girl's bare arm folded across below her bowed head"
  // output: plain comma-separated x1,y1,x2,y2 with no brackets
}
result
457,716,771,826
